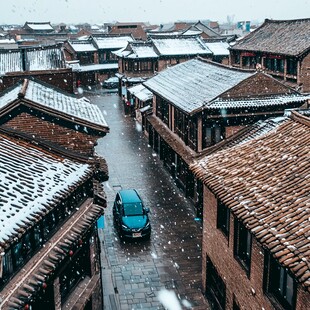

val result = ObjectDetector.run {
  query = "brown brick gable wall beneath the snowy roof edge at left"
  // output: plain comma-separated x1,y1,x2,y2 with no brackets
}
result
4,112,99,155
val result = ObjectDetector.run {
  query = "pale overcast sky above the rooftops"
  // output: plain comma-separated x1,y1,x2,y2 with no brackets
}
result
0,0,310,24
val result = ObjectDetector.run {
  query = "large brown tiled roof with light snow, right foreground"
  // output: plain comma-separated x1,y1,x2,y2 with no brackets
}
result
191,112,310,291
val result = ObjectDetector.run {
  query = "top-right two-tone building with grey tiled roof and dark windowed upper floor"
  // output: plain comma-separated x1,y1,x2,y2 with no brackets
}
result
230,19,310,93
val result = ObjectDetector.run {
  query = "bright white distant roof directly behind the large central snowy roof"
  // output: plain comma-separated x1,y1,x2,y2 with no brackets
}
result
151,36,211,56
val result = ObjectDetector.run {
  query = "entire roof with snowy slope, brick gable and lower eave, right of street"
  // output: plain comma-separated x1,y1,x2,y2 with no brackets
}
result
143,58,309,114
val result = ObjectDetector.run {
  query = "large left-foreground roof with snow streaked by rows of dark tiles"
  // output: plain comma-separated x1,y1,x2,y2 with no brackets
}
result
0,134,91,243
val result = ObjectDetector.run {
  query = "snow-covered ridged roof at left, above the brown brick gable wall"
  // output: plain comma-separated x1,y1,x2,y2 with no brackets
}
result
0,80,108,129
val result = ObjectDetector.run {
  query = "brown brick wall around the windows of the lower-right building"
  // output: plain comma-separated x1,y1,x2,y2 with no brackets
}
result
202,186,309,310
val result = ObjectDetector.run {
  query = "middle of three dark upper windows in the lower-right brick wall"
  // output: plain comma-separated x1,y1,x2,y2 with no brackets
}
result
234,219,252,274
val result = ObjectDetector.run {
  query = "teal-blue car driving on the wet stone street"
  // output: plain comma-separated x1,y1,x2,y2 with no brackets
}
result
113,189,151,239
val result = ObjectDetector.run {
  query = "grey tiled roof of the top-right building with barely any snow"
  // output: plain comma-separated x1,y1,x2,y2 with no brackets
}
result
231,18,310,56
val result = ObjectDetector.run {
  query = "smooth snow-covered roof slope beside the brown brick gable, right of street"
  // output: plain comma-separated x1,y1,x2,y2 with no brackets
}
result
144,59,254,113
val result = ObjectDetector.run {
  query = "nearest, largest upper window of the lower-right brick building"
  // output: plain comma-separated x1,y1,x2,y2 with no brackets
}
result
264,251,296,309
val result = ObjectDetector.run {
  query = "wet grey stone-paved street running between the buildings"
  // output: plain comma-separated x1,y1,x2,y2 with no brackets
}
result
86,92,209,310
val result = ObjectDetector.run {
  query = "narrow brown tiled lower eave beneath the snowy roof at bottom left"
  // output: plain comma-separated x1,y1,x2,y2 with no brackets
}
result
0,199,104,309
